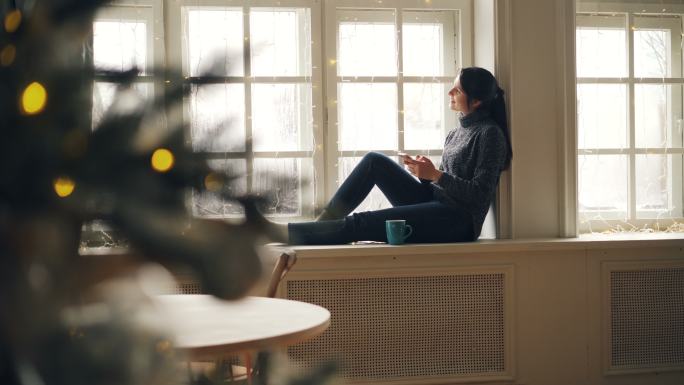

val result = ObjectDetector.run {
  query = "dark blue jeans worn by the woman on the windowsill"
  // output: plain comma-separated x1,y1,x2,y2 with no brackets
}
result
288,152,473,245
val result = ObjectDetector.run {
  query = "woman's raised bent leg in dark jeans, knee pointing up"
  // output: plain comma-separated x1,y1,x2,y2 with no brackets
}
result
319,152,432,220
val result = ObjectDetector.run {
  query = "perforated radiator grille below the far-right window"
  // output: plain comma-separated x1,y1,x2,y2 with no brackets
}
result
610,268,684,369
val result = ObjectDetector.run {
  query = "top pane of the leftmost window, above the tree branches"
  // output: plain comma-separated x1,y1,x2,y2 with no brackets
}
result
93,21,147,71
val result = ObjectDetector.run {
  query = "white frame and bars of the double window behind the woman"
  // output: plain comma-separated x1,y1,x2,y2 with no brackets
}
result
120,0,473,221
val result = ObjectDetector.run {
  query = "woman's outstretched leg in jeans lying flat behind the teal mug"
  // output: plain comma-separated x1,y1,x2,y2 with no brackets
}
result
289,201,473,245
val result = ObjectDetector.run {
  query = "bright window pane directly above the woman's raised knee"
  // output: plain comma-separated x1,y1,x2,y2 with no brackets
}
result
337,83,397,150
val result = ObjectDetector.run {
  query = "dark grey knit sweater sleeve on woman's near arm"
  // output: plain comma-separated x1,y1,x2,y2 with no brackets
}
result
435,126,508,204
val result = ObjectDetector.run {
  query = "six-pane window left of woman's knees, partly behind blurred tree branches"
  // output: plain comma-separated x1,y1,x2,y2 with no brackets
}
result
172,1,320,217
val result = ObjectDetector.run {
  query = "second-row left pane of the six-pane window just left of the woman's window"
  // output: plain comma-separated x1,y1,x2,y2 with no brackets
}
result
190,84,245,152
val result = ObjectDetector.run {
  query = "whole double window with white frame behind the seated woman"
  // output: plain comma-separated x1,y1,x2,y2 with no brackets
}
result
164,0,472,221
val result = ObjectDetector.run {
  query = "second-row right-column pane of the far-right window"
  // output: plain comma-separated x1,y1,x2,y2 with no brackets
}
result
634,84,682,148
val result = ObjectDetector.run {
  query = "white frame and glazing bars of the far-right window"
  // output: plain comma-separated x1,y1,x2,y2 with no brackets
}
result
576,2,684,233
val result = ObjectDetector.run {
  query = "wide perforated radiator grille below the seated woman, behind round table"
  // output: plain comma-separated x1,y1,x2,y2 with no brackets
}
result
287,273,506,379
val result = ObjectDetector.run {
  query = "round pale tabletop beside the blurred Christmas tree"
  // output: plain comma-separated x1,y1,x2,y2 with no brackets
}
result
154,294,330,358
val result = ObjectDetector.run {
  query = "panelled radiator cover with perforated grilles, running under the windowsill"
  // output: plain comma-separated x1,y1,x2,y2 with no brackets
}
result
162,238,684,385
